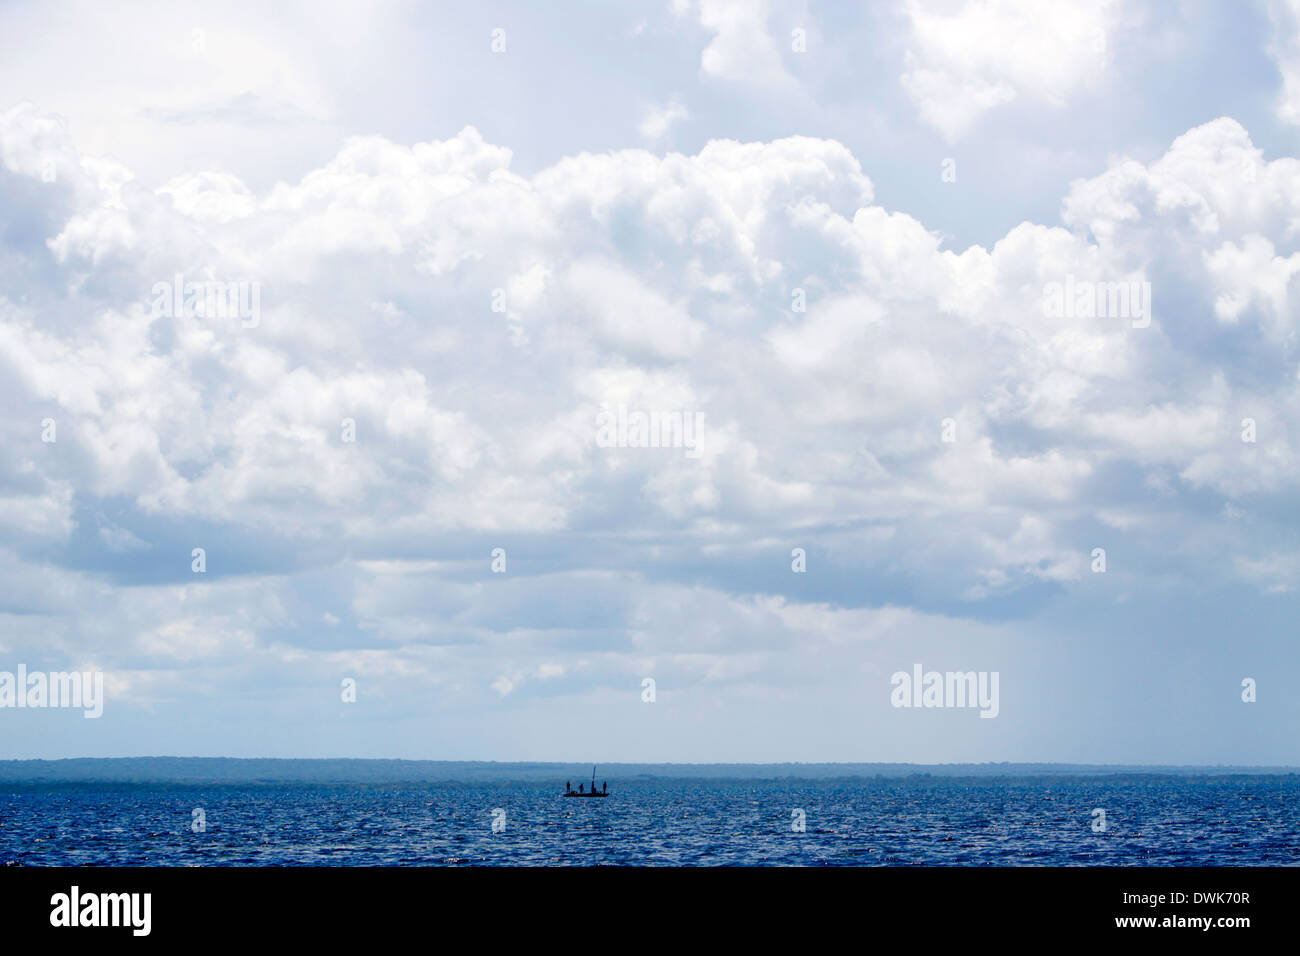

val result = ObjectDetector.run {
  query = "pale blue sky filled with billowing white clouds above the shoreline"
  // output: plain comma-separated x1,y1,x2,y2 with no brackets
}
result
0,0,1300,765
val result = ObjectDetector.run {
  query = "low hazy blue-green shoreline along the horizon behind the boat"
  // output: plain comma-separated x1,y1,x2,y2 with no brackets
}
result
0,757,1300,787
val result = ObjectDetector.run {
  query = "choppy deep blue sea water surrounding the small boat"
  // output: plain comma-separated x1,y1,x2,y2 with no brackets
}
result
0,778,1300,866
